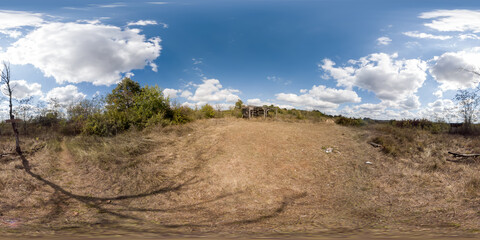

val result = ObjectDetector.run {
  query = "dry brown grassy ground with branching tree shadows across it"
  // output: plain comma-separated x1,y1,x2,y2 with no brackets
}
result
0,119,480,238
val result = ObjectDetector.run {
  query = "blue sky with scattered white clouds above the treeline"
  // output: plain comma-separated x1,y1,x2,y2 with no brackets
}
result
0,0,480,120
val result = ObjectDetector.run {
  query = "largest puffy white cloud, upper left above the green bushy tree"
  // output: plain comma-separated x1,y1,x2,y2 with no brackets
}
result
2,22,161,85
